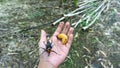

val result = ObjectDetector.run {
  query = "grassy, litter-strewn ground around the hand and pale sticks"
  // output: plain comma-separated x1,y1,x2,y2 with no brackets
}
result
0,0,120,68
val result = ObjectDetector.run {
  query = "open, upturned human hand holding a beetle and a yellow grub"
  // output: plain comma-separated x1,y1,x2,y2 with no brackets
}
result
38,22,74,68
